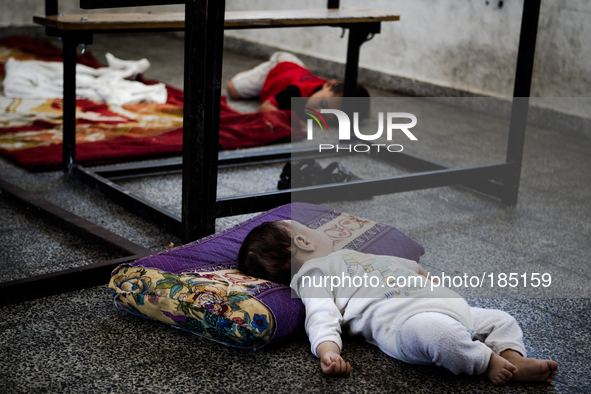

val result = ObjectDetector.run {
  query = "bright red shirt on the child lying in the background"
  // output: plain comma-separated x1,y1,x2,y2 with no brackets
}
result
260,62,326,107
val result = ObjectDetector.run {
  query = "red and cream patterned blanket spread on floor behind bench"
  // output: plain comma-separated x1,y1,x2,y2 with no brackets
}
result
0,36,303,171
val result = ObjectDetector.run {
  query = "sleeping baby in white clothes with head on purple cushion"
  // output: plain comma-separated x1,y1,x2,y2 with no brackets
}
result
238,220,558,385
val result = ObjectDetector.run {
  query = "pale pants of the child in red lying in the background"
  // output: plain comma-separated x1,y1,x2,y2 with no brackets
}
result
232,52,305,99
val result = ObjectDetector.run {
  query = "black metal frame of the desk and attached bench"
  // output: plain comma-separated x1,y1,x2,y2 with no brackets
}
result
0,0,541,300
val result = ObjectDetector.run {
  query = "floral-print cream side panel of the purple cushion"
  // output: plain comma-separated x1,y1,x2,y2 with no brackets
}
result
108,266,275,348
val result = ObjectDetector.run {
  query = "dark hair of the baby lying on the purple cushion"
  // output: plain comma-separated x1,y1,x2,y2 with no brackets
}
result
238,222,295,285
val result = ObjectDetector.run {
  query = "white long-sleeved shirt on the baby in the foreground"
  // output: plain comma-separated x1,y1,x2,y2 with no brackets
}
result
291,250,473,359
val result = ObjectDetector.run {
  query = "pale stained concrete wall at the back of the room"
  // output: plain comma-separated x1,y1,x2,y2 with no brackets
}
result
0,0,591,117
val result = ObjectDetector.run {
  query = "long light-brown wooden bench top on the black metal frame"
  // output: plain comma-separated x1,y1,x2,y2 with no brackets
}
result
33,8,400,31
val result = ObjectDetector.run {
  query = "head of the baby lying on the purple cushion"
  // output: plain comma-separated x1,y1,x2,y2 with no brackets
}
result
238,220,334,284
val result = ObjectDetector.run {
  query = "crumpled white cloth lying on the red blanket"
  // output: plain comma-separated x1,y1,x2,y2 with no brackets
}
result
4,53,167,105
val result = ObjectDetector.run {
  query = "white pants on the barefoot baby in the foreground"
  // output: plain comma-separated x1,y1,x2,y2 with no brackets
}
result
400,308,526,375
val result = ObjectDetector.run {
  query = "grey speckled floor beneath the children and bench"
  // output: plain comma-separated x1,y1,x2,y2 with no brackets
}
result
0,35,591,393
